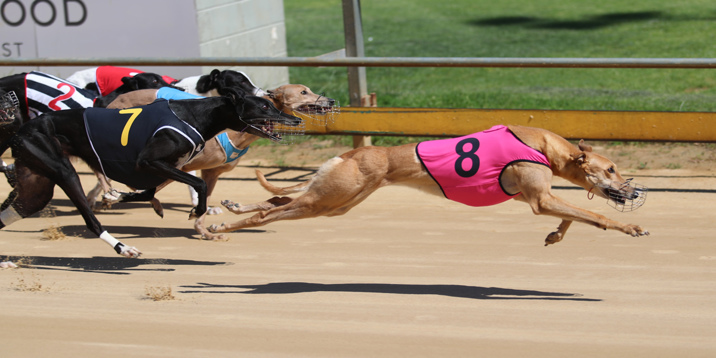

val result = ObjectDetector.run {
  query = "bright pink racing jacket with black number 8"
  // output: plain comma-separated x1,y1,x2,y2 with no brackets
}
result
415,125,550,206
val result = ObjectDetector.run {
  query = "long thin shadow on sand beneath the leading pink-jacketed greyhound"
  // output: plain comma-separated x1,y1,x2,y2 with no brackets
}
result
179,282,601,302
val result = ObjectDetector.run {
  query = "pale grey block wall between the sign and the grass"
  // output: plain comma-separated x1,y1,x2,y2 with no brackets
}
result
195,0,288,89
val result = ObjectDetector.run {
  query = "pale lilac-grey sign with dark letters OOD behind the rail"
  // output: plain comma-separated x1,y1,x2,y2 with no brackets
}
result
0,0,200,78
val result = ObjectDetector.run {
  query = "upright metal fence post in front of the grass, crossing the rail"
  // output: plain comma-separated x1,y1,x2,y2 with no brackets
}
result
343,0,371,148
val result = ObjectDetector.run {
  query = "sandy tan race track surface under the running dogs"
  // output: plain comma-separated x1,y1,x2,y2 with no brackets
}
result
0,155,716,358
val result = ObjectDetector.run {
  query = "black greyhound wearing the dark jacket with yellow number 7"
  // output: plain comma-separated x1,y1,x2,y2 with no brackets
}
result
0,90,301,268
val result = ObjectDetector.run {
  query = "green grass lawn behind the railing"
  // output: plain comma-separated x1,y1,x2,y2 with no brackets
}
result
284,0,716,111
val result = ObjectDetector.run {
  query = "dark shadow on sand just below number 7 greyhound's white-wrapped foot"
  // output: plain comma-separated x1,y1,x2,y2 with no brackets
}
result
2,256,231,275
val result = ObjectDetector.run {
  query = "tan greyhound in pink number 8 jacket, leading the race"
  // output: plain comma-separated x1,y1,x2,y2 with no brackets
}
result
209,126,649,245
